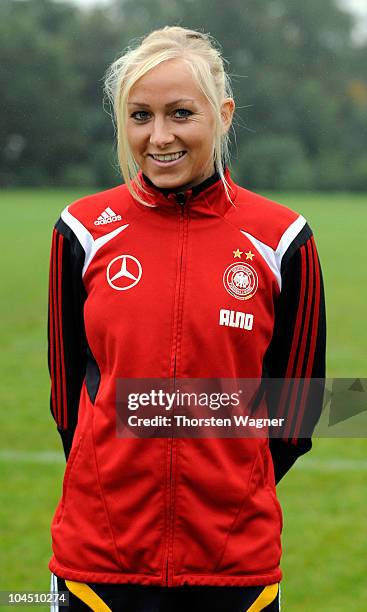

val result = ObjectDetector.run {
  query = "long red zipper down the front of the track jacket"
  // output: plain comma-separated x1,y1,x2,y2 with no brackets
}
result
165,192,188,586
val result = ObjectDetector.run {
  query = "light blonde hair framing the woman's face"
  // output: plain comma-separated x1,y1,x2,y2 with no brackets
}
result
104,26,233,206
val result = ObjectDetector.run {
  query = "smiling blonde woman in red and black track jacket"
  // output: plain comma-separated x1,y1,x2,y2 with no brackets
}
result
49,27,325,612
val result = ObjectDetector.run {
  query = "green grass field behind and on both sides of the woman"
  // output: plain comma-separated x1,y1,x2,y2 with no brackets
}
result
0,190,367,612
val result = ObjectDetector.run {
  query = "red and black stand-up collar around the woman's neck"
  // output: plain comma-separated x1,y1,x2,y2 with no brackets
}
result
133,167,237,214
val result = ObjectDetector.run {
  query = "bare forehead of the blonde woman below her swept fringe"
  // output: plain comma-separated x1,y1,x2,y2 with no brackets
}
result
128,60,207,104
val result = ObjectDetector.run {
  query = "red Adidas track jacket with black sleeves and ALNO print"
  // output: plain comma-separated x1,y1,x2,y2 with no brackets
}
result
48,169,325,586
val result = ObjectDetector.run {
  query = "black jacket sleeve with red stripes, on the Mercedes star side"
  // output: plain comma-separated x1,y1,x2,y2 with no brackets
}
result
48,218,87,459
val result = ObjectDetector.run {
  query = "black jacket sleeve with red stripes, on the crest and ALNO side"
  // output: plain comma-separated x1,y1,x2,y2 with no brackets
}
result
264,224,326,483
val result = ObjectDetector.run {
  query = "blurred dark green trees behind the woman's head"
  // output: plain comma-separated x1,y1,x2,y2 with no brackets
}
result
0,0,367,191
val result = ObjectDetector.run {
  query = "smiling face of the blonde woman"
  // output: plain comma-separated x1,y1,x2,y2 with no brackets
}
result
127,60,234,189
